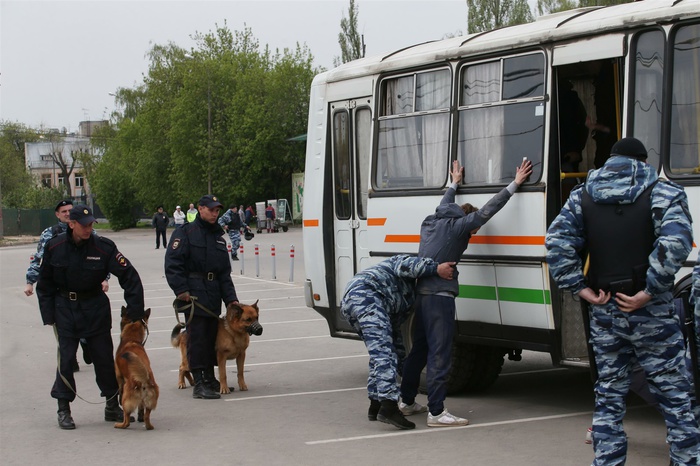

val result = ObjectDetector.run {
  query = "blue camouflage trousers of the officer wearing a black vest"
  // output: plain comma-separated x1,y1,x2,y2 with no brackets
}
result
590,292,700,466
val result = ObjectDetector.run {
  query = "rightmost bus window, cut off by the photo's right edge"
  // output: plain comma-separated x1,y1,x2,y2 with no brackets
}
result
669,24,700,177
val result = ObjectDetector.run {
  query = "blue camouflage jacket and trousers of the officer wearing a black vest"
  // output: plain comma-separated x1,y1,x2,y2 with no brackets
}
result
545,155,700,466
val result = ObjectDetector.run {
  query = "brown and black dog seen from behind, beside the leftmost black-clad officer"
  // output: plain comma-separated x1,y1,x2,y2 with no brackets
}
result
114,307,159,430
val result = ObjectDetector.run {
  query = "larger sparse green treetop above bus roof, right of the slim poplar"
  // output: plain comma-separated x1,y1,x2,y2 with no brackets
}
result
467,0,534,34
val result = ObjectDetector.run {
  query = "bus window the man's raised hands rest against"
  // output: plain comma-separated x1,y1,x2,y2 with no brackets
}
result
458,53,544,185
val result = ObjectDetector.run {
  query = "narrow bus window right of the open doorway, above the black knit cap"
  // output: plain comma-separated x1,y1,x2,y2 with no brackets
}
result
632,30,666,168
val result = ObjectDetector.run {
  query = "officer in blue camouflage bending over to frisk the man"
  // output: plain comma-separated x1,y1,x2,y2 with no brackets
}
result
340,255,455,429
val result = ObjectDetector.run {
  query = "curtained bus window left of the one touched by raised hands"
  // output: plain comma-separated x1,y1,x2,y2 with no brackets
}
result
374,69,452,189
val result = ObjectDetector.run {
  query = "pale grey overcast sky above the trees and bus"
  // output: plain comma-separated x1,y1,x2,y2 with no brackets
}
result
0,0,467,131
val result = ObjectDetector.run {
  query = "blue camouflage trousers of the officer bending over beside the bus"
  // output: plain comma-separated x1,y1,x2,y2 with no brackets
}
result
340,290,399,401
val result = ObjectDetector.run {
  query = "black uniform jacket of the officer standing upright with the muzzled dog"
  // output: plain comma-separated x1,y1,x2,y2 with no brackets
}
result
165,214,238,317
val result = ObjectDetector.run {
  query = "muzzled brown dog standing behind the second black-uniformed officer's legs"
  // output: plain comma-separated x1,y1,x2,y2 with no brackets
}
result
170,301,262,393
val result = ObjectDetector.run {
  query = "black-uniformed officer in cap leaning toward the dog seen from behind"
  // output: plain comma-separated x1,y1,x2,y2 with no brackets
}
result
36,205,144,429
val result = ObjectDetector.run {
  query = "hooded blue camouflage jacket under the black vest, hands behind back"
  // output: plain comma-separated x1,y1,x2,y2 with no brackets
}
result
545,156,693,296
